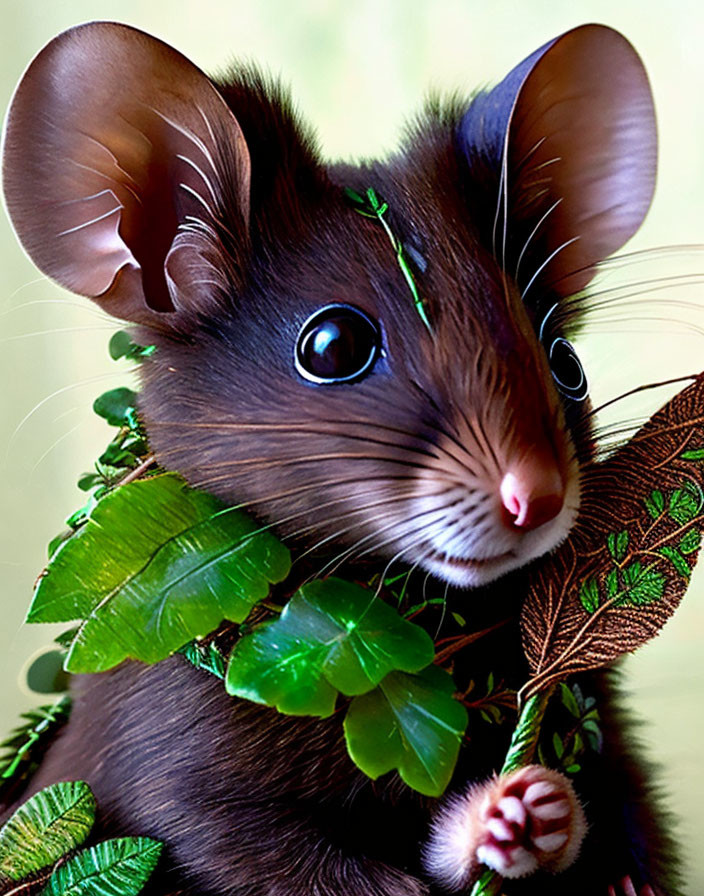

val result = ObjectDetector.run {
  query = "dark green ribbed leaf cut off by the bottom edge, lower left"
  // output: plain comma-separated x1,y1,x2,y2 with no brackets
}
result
42,837,163,896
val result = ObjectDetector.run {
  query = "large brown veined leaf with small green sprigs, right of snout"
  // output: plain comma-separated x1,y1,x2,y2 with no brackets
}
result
521,373,704,700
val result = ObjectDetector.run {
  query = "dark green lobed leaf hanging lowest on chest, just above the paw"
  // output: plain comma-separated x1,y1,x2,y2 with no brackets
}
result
345,666,467,796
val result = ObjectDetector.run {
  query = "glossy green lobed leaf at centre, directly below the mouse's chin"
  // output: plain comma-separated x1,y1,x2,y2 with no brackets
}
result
227,579,434,716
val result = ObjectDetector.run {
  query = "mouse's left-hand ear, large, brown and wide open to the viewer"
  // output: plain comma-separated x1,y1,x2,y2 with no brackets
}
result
3,22,250,328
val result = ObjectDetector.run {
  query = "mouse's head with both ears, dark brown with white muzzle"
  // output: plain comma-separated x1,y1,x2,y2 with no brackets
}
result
4,23,655,586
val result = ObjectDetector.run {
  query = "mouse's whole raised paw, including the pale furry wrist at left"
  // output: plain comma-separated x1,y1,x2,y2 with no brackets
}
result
425,765,584,896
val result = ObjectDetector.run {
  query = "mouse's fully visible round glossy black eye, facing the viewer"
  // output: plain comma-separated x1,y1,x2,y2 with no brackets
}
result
296,305,381,383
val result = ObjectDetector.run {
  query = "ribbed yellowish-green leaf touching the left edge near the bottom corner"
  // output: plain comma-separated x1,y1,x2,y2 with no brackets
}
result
0,781,95,880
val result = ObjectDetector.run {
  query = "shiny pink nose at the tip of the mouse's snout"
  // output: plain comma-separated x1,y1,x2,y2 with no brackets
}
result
500,465,565,532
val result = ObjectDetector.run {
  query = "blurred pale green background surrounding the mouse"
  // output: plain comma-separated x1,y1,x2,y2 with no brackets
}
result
0,0,704,896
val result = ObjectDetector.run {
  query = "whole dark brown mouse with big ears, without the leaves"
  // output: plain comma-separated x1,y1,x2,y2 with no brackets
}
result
0,22,679,896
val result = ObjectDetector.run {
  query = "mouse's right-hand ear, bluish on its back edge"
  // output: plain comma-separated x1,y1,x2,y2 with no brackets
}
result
459,25,657,295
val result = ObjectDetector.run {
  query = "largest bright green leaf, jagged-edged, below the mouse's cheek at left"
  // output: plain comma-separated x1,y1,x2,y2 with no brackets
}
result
27,474,290,672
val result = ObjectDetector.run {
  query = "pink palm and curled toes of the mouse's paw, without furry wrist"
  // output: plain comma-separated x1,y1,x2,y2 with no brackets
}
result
476,765,586,877
